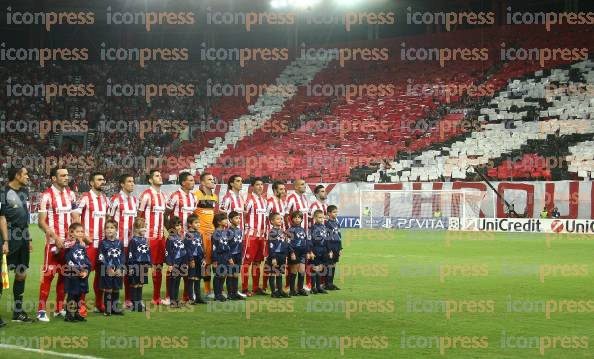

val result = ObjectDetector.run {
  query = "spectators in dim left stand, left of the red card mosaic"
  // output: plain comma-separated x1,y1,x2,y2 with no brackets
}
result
0,62,238,197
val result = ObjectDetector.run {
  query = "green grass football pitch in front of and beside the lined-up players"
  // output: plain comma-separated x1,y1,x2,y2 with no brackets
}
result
0,226,594,359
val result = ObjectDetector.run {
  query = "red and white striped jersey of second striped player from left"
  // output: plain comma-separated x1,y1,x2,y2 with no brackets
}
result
77,191,109,248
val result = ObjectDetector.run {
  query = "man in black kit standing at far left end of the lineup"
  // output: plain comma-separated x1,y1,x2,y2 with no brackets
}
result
0,167,33,327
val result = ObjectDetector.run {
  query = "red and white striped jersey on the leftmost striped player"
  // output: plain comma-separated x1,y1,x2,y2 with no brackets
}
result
39,186,76,240
